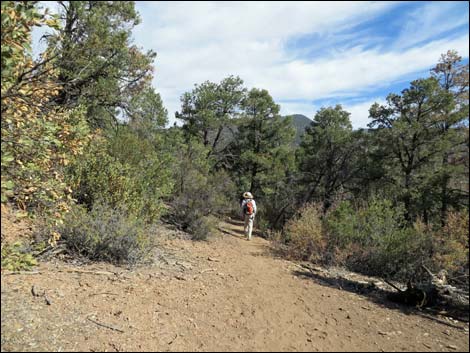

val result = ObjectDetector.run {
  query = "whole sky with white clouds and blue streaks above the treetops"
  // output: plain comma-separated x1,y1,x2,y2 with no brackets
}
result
33,1,469,128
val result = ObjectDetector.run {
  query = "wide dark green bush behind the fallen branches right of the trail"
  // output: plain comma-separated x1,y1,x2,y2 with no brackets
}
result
326,199,430,279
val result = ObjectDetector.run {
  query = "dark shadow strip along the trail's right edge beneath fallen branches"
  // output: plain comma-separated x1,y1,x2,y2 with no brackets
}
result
292,269,468,330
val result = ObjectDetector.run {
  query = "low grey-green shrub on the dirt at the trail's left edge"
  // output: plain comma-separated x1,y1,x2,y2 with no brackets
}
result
58,202,153,264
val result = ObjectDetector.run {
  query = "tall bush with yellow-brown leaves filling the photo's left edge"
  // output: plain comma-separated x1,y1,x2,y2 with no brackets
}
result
1,1,89,243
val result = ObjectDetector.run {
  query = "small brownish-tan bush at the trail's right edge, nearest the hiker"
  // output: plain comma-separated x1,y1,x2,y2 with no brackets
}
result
283,204,325,261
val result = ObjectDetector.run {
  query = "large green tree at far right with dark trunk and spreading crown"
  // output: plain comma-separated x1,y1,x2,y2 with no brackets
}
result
369,78,455,223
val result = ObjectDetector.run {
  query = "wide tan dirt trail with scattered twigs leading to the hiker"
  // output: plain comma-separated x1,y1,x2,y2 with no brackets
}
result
1,222,469,351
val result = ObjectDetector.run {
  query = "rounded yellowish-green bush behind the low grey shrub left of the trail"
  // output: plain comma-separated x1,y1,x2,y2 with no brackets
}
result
69,126,173,222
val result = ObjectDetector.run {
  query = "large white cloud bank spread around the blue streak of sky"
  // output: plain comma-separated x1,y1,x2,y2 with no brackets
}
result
135,2,468,124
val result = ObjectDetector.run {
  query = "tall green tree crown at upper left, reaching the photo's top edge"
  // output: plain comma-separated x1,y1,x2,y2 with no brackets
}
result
48,1,155,128
